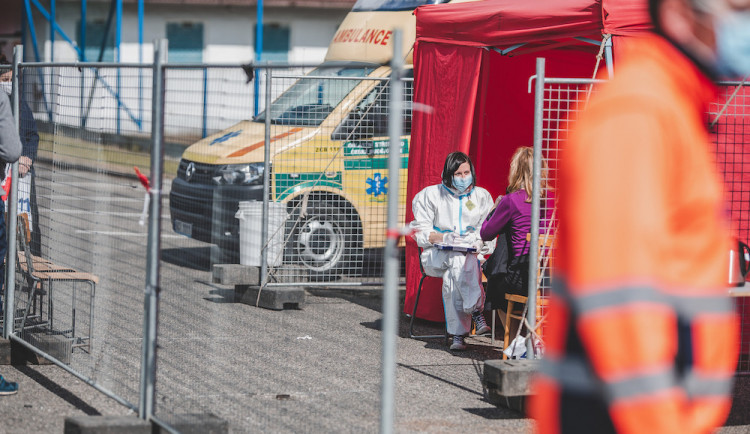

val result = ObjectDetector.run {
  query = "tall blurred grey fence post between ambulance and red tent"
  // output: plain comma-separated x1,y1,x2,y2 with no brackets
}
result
380,29,404,434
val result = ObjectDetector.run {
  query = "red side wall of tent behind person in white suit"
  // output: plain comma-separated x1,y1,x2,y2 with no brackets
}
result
404,42,483,321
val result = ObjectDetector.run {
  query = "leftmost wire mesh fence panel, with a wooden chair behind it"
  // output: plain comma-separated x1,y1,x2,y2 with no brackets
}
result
6,65,156,408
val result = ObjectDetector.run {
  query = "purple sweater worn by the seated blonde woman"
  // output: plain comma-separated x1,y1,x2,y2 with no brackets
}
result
479,190,551,256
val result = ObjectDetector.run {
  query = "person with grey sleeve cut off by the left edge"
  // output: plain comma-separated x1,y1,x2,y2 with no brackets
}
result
0,74,21,395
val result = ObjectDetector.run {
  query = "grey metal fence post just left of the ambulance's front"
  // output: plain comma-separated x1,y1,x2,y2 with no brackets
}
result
138,39,167,420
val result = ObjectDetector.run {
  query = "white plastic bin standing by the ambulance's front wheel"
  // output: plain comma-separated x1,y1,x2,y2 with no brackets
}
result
234,200,287,267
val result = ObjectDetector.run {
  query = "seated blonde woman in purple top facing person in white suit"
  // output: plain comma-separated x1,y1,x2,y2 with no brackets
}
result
480,146,546,334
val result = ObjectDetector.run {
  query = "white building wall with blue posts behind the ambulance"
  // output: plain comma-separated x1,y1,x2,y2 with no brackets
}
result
36,3,348,143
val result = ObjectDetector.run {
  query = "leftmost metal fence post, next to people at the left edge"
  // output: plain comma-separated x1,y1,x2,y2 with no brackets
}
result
0,46,23,339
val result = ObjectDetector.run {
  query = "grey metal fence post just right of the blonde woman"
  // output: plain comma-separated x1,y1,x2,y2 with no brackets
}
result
526,57,544,359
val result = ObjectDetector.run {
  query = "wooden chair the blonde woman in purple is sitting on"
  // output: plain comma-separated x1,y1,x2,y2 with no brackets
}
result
502,234,555,359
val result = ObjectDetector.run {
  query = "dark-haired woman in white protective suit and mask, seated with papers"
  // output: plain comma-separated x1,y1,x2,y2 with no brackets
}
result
410,152,495,351
